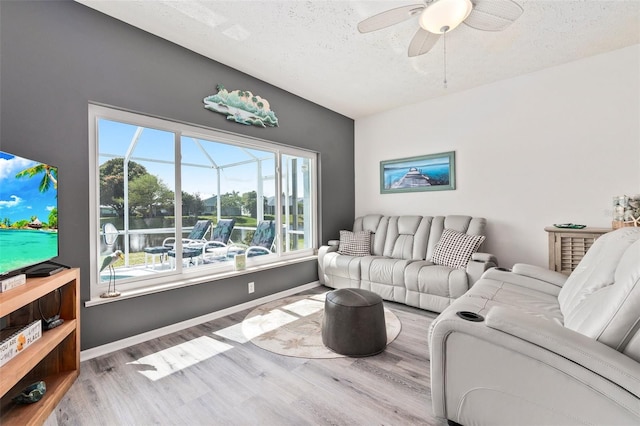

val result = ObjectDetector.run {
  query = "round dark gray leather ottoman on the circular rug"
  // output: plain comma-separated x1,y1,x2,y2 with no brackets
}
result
322,288,387,357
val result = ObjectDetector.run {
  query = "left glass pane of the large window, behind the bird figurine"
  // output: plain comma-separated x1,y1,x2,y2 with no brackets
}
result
98,119,176,282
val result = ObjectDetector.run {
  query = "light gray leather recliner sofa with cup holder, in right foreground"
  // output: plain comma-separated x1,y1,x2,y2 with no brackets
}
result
429,228,640,425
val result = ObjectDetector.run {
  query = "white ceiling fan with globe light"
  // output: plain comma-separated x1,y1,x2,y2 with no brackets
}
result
358,0,523,57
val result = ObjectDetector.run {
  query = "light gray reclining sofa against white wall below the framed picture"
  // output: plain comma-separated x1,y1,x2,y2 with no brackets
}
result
318,215,497,312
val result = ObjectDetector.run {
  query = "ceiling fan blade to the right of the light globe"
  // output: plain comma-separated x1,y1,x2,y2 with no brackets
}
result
464,0,524,31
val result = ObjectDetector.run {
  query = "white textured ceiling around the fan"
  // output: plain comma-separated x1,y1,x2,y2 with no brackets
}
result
77,0,640,118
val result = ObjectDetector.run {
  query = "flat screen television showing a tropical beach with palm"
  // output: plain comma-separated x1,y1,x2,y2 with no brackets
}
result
0,151,59,277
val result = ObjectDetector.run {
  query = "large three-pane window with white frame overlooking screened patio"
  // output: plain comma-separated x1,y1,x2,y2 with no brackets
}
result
89,105,317,299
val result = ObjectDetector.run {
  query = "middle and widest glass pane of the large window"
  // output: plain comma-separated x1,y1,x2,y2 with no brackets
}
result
181,136,276,267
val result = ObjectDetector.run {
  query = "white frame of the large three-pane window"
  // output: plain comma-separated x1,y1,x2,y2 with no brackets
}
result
86,103,320,306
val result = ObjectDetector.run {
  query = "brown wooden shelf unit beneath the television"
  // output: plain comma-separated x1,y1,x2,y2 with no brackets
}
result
0,268,80,425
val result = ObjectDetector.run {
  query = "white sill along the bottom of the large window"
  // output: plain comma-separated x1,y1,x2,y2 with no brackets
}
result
84,255,318,308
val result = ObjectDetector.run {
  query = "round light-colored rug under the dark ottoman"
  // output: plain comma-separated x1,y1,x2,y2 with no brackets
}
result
242,293,402,358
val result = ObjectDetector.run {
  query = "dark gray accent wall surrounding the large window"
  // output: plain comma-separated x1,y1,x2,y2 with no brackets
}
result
0,1,354,350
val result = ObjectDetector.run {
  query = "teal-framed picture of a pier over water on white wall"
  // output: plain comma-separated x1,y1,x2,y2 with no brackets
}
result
380,151,456,194
